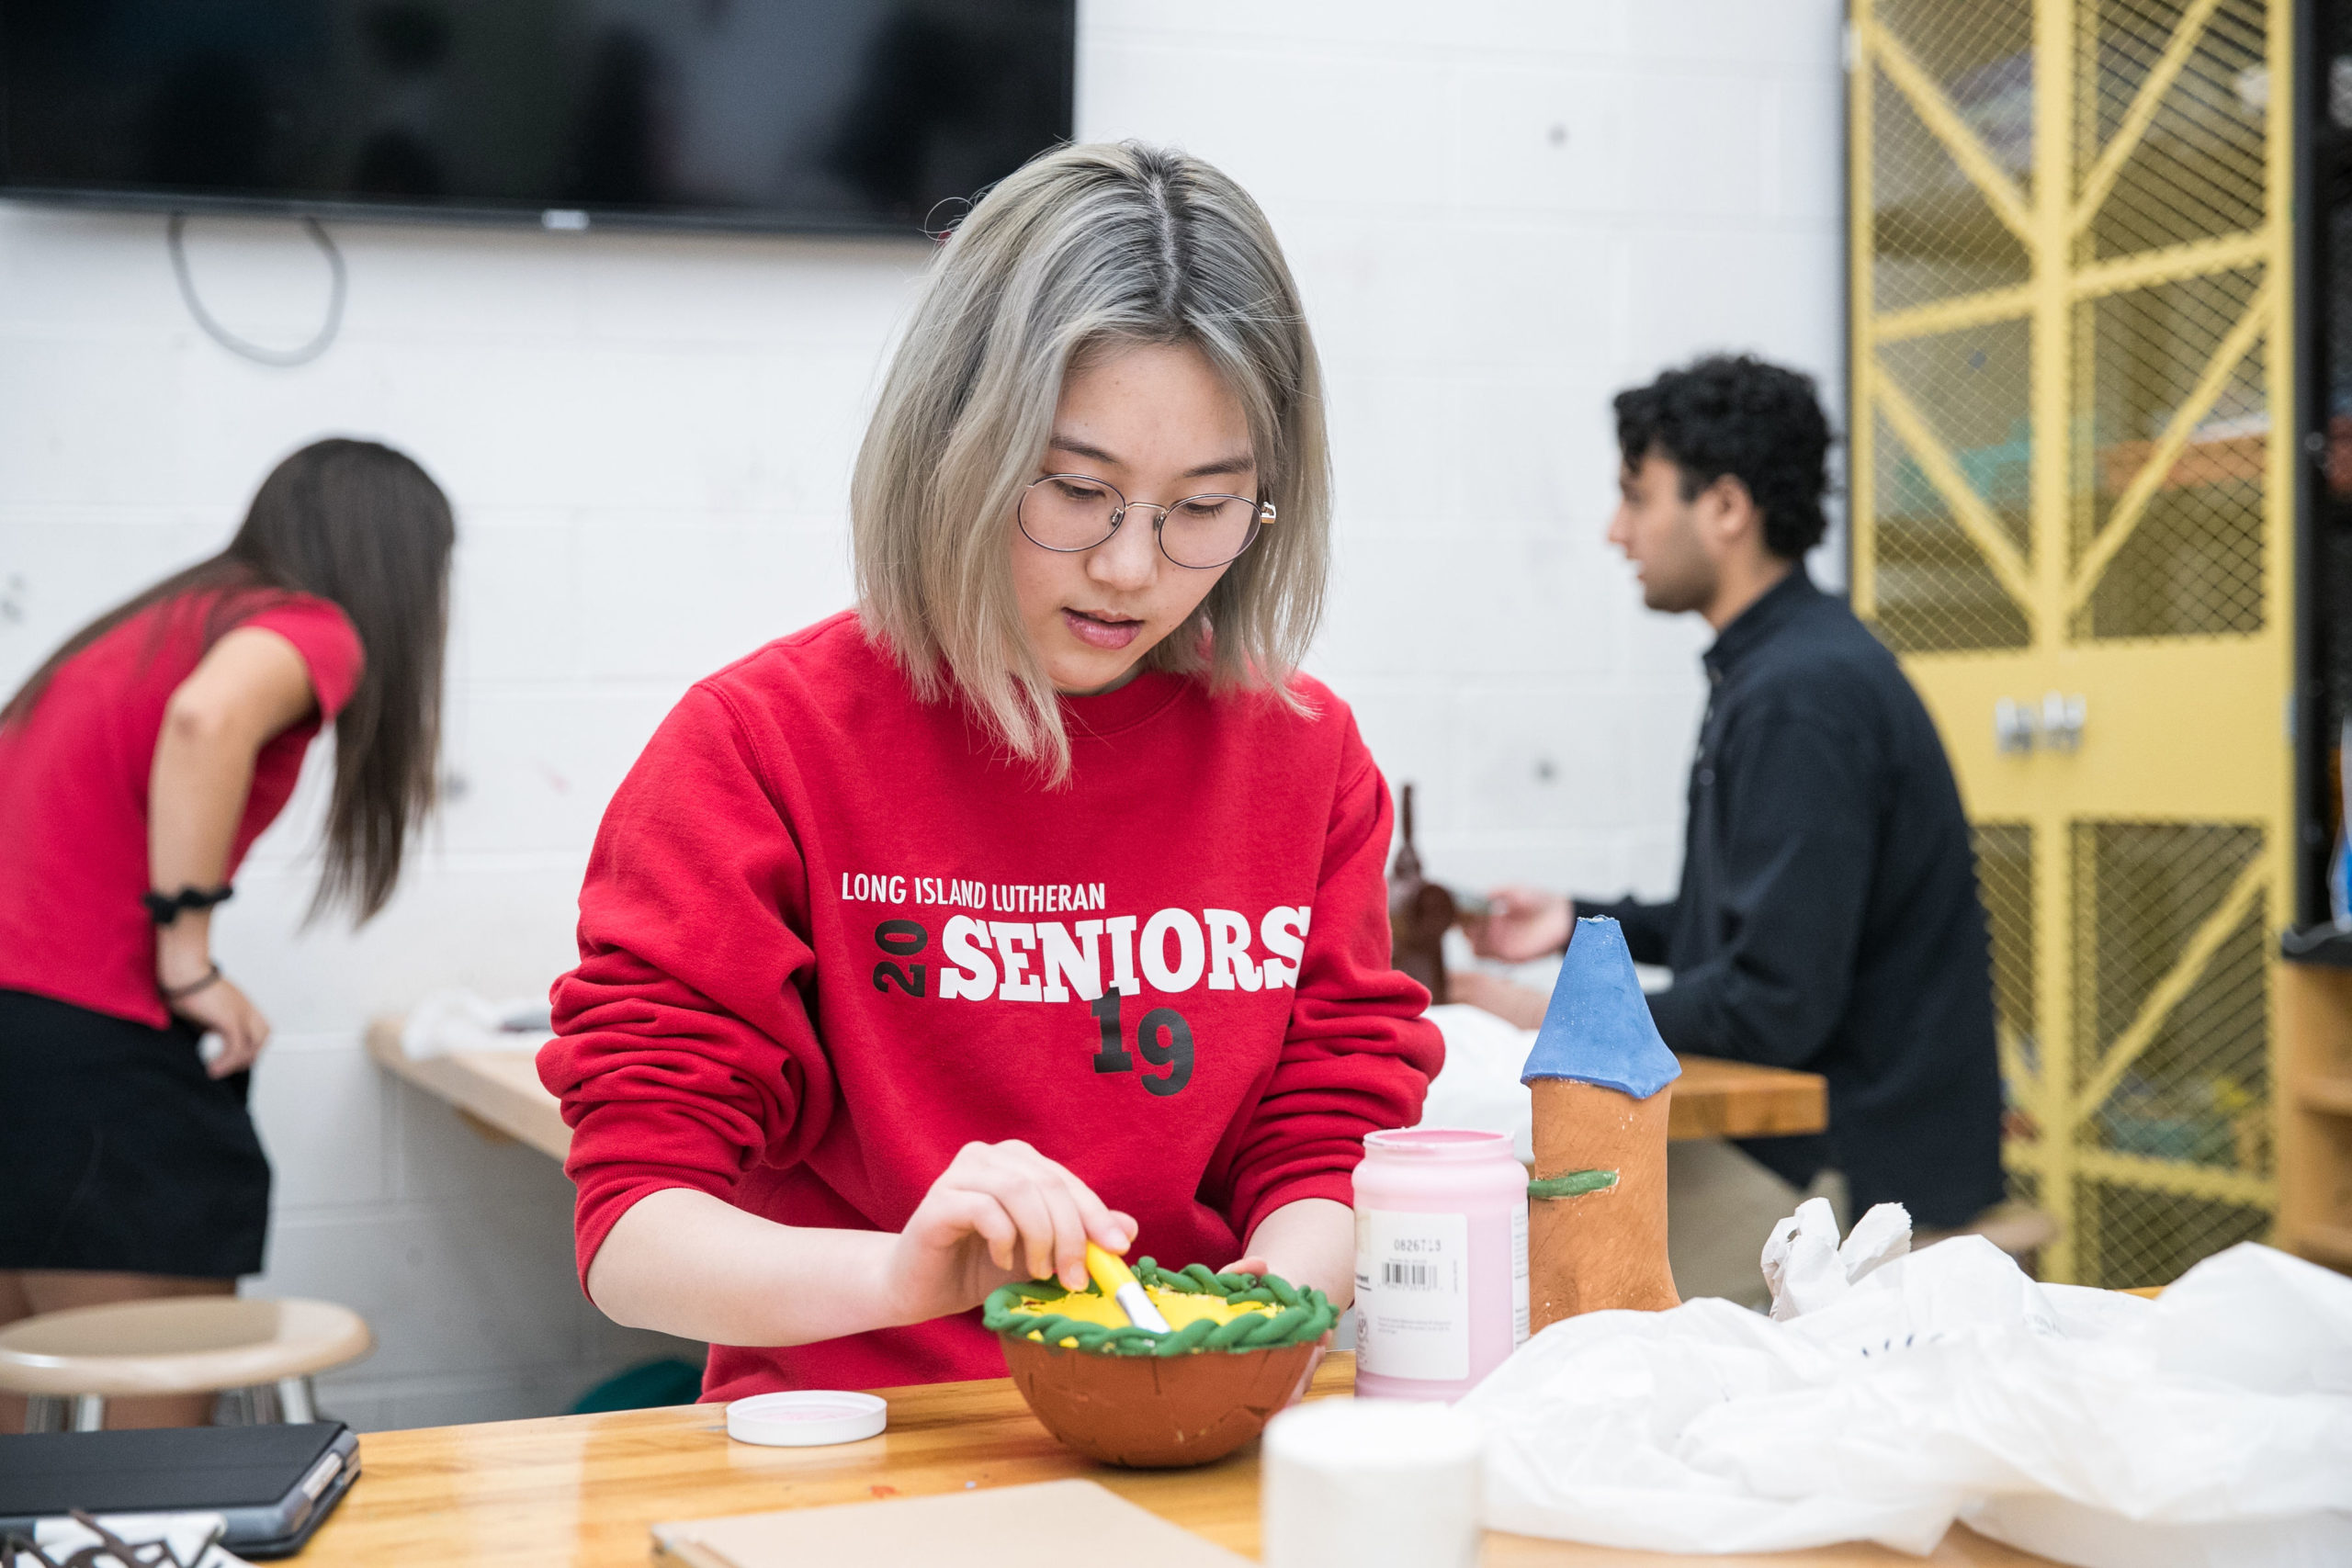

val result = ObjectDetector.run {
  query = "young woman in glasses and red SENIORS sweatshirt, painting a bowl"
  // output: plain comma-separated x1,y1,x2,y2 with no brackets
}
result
538,143,1442,1399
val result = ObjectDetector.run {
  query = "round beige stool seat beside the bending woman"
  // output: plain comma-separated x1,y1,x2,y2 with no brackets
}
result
0,1295,377,1399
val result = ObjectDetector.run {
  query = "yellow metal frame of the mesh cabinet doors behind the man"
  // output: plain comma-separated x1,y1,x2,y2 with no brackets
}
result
1849,0,2298,1283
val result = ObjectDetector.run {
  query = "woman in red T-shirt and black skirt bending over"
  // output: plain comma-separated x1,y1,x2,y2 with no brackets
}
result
0,440,454,1429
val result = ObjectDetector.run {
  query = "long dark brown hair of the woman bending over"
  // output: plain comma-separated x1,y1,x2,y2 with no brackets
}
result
0,440,457,921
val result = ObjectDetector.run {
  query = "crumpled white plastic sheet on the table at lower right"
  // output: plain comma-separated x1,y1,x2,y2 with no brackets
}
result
1461,1220,2352,1568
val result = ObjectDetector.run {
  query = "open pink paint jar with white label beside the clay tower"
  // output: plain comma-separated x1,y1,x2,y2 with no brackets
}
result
1355,1126,1526,1399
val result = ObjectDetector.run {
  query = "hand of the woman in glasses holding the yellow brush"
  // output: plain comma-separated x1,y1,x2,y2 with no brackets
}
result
885,1138,1136,1324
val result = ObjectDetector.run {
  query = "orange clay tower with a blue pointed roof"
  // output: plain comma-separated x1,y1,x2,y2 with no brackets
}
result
1520,919,1681,1331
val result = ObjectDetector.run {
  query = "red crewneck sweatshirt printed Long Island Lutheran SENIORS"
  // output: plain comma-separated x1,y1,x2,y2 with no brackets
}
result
538,614,1444,1399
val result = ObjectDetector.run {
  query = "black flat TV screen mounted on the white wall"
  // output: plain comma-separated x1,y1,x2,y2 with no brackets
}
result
0,0,1075,232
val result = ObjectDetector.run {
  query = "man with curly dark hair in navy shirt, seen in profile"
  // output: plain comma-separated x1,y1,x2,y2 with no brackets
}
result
1461,355,2002,1258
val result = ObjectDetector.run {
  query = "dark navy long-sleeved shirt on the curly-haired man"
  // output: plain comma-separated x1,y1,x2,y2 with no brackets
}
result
1576,567,2004,1227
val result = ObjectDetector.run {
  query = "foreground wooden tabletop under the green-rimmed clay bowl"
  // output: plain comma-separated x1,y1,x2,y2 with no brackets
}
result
299,1354,2041,1568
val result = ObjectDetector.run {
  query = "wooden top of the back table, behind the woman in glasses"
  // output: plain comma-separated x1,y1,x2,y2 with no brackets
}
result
367,1018,1830,1159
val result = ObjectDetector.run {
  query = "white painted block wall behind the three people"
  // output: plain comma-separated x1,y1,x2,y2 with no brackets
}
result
0,0,1841,1425
